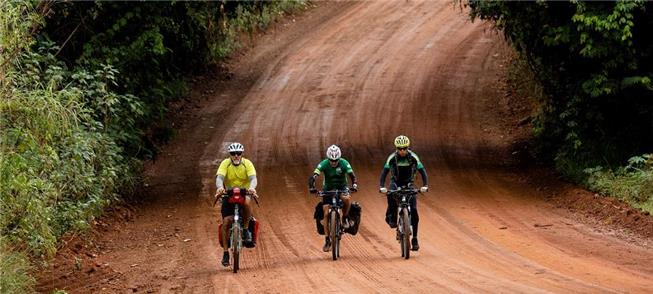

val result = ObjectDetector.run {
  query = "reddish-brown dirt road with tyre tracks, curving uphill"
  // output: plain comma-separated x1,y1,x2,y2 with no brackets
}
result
39,0,653,293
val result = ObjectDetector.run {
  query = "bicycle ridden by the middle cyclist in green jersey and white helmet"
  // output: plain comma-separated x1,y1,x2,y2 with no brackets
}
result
318,188,349,260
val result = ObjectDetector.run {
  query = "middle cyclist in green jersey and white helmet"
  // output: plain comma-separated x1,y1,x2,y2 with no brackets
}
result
308,145,358,252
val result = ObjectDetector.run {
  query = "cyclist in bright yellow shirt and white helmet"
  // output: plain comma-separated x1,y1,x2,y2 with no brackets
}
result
215,142,258,266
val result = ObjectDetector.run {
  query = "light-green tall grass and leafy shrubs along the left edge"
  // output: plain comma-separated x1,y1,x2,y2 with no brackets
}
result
0,1,138,293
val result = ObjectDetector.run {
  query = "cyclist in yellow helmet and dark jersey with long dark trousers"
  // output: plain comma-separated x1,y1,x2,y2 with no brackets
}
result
379,135,429,251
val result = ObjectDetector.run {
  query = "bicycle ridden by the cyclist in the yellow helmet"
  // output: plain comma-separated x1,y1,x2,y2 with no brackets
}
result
387,187,419,259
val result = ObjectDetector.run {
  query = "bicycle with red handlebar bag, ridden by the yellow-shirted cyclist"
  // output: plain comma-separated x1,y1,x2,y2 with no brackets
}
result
214,187,258,273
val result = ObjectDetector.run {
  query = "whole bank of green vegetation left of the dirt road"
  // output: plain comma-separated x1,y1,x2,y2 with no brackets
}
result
0,1,306,293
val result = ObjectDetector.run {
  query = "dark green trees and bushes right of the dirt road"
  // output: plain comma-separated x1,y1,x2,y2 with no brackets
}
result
464,0,653,213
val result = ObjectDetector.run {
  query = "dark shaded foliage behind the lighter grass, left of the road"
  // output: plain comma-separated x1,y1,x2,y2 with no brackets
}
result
39,0,304,158
